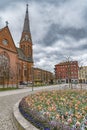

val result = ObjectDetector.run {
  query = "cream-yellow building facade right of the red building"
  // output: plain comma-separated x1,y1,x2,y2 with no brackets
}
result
78,66,87,83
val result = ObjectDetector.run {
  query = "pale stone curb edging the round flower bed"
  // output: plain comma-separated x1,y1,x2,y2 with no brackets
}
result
13,101,39,130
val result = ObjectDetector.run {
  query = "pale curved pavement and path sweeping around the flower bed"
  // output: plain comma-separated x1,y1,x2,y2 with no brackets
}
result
0,86,59,130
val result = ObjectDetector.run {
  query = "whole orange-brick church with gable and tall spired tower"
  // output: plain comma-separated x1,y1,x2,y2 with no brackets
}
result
0,5,33,84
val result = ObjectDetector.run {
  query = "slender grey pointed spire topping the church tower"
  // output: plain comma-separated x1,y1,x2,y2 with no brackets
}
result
23,4,30,33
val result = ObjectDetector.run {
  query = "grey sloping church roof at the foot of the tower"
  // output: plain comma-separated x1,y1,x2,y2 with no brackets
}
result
17,48,33,62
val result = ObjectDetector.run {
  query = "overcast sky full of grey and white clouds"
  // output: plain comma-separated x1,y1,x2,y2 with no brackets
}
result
0,0,87,72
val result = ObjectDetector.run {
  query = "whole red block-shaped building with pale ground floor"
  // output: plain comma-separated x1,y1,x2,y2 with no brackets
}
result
55,61,78,83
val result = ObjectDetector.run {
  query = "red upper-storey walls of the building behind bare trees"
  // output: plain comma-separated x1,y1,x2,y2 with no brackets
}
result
55,61,78,79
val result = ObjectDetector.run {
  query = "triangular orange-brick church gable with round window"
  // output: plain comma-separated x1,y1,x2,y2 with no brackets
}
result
0,26,17,53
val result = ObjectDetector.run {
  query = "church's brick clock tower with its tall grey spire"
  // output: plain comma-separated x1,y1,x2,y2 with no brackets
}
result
20,4,33,62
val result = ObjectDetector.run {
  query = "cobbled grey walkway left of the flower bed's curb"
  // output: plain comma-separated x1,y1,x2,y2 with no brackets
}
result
0,89,29,130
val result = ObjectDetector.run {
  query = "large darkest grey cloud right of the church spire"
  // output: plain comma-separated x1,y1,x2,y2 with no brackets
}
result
43,24,87,46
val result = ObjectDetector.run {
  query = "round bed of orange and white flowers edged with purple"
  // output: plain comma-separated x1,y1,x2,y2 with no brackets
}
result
19,90,87,130
